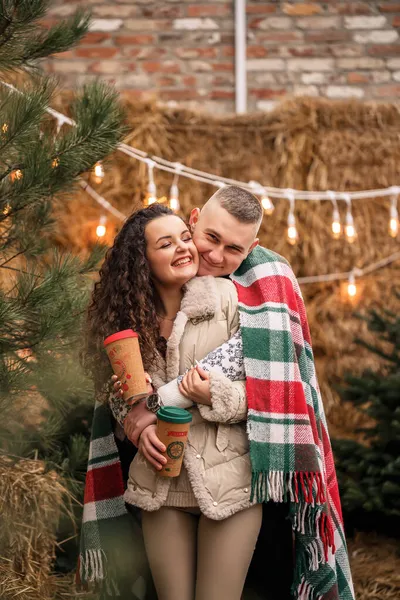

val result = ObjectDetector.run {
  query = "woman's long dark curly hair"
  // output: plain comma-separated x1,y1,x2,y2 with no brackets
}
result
82,204,174,399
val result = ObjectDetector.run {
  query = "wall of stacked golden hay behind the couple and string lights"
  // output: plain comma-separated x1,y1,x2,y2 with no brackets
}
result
50,97,400,437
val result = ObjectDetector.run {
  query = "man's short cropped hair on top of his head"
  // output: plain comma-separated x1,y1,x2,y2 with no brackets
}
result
210,185,263,225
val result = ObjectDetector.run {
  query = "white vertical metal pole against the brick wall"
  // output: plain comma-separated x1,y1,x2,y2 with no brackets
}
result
235,0,247,114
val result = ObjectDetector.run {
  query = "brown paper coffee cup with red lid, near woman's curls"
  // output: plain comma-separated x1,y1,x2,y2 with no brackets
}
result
104,329,147,401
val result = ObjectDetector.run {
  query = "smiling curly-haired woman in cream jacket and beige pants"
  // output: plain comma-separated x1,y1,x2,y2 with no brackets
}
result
88,205,262,600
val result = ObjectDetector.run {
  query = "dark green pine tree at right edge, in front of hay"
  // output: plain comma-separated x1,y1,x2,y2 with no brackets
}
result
333,292,400,535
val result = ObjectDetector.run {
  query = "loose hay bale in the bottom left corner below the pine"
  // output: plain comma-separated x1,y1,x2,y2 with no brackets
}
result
0,456,66,600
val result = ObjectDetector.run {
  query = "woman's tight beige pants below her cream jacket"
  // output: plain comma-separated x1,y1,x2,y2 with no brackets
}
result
142,504,262,600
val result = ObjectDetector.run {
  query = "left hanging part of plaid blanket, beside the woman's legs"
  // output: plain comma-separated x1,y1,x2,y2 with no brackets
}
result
77,402,148,599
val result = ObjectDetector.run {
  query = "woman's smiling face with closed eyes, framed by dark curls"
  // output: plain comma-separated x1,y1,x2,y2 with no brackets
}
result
145,215,199,287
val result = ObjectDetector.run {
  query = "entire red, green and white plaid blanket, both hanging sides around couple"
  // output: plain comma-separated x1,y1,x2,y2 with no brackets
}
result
77,247,354,600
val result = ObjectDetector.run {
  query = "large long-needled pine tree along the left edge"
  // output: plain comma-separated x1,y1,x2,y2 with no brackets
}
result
0,0,123,580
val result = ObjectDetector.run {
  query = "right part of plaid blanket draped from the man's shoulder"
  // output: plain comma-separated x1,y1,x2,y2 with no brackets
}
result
231,247,354,600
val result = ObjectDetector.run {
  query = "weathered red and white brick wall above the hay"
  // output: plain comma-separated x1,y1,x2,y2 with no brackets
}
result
46,0,400,112
